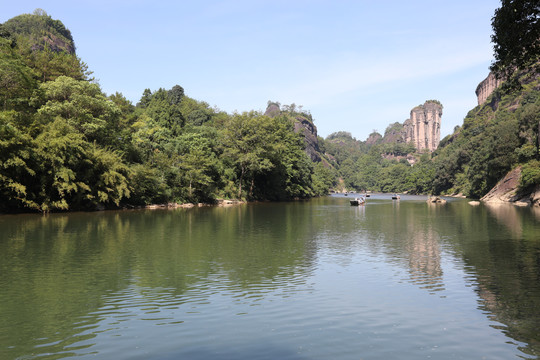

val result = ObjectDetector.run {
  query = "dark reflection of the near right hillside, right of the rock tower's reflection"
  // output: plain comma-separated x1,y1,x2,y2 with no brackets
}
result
438,203,540,358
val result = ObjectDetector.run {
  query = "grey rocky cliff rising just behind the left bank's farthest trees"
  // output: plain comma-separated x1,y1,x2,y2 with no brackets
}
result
264,103,322,162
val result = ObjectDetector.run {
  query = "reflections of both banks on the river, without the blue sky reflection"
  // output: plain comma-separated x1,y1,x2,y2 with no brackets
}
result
0,196,540,358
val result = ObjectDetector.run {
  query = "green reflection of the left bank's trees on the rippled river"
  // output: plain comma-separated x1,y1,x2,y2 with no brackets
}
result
0,206,315,358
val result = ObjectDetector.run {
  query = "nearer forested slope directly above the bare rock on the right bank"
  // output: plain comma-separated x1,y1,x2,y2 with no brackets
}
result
433,72,540,198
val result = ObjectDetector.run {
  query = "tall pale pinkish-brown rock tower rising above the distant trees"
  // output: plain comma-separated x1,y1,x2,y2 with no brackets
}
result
403,100,442,152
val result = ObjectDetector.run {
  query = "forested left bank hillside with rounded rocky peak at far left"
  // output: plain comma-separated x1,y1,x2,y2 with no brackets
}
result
0,10,332,212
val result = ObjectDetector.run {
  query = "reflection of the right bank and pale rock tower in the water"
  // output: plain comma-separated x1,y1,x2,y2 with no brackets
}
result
332,199,540,357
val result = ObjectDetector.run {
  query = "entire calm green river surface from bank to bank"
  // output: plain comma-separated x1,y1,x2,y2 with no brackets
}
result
0,195,540,359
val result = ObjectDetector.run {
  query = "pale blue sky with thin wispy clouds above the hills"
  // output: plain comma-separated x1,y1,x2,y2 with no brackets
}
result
0,0,500,140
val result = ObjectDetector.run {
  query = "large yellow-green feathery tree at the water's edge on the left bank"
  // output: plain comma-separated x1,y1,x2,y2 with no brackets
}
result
28,117,130,212
